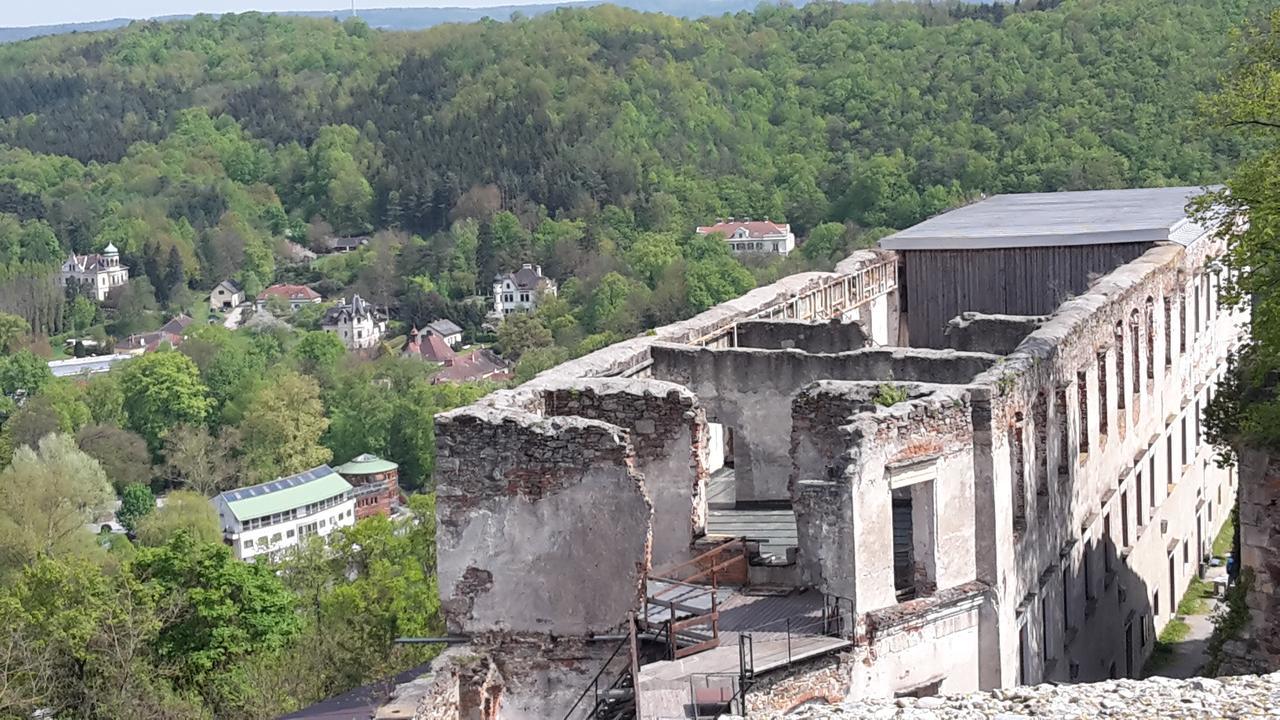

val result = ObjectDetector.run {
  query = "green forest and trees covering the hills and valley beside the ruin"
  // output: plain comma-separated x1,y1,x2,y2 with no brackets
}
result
0,0,1270,720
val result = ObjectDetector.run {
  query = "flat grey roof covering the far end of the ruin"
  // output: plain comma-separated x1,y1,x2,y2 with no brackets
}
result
881,187,1207,250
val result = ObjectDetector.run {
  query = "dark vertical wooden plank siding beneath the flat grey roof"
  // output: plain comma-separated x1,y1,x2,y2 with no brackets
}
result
899,242,1152,347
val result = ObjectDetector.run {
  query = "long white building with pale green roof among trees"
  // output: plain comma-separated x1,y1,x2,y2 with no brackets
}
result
211,465,356,560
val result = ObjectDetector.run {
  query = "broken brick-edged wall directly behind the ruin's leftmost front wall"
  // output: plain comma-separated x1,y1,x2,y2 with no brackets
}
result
543,378,708,568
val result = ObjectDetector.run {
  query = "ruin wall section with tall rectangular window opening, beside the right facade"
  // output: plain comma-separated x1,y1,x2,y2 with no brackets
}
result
791,380,975,612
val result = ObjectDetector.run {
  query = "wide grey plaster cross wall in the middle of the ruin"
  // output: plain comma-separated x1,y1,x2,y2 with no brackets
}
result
650,343,998,501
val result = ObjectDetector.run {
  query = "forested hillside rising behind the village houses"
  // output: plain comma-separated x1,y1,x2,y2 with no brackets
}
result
0,0,1266,351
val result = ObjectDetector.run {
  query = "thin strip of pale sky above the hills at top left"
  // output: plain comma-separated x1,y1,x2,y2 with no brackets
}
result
8,0,560,27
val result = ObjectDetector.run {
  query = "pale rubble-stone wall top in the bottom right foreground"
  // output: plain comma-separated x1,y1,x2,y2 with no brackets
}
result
733,673,1280,720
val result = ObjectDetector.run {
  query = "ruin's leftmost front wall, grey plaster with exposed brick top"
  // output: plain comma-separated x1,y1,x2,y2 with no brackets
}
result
435,407,653,635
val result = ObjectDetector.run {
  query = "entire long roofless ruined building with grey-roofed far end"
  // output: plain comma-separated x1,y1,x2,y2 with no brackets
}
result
397,187,1248,720
